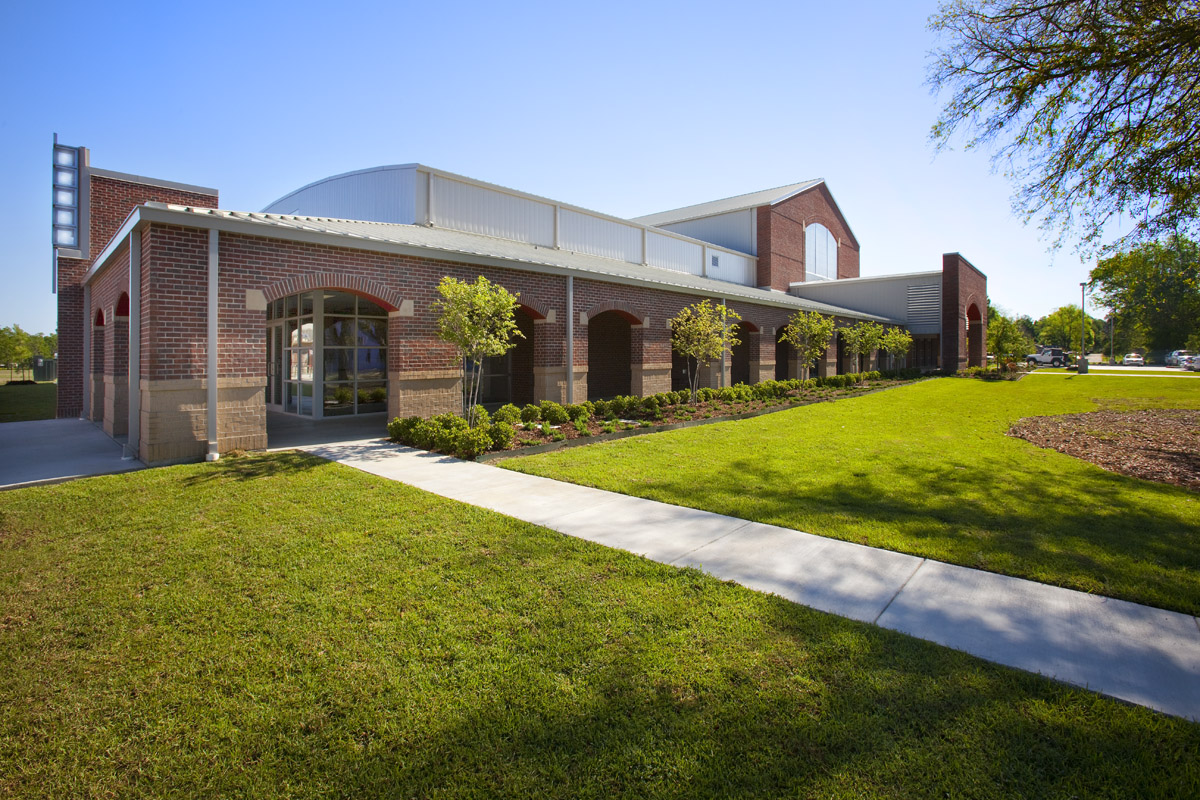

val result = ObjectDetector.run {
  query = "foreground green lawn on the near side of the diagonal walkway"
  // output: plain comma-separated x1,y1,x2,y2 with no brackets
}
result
0,455,1200,798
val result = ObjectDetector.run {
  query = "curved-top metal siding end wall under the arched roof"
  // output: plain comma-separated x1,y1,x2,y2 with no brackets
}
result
264,168,416,224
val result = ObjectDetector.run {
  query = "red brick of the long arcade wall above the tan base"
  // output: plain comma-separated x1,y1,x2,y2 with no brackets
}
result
131,224,864,412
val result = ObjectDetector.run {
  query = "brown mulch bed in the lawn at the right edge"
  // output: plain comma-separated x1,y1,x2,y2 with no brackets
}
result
1008,409,1200,492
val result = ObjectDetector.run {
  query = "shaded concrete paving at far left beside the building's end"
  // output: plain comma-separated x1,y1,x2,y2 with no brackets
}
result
0,420,145,489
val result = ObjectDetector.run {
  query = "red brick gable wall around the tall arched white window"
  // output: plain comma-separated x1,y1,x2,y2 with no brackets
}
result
758,184,858,291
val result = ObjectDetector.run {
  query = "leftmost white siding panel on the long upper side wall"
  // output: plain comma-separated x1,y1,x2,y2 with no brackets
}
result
432,175,554,247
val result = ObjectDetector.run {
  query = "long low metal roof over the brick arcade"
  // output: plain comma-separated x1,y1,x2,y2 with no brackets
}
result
84,203,895,321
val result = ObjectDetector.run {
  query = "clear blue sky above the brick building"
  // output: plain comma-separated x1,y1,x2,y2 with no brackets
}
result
0,0,1092,332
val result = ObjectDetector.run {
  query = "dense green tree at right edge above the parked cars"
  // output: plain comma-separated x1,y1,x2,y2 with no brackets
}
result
1088,237,1200,350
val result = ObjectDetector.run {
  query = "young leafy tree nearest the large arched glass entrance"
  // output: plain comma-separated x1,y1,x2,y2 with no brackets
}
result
433,275,524,426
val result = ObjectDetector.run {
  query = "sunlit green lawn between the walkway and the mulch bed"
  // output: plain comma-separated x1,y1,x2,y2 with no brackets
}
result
503,375,1200,614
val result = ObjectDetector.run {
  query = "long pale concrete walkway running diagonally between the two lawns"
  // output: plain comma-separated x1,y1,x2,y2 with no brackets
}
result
304,439,1200,721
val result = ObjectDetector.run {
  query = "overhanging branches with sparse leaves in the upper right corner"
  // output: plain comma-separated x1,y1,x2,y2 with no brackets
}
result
929,0,1200,247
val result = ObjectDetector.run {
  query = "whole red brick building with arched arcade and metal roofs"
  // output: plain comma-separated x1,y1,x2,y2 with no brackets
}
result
54,143,986,463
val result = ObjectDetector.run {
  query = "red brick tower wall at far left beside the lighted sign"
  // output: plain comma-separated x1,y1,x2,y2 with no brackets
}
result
56,175,218,417
